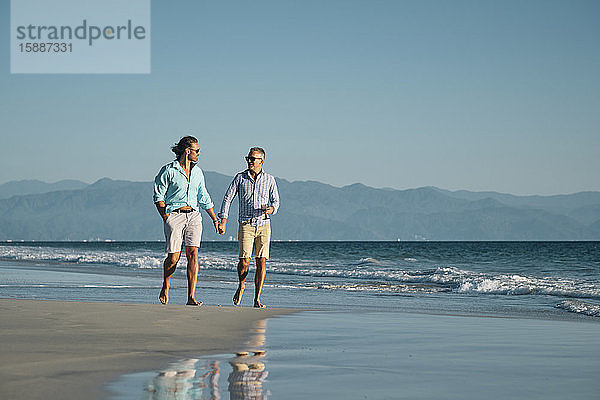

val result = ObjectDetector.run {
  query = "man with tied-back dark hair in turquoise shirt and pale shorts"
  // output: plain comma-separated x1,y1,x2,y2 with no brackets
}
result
153,136,219,306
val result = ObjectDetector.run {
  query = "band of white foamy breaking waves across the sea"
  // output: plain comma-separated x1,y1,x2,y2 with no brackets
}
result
0,246,600,300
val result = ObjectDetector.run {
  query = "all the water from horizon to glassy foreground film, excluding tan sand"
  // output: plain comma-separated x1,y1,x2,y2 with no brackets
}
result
0,242,600,400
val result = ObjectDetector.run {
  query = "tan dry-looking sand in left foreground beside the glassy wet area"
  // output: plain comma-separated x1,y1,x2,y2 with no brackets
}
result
0,299,293,400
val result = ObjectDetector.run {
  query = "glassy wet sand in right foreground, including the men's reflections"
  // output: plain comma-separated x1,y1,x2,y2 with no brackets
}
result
109,311,600,400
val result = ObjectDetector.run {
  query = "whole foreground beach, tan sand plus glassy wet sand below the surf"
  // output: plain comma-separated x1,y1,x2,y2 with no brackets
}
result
0,299,600,400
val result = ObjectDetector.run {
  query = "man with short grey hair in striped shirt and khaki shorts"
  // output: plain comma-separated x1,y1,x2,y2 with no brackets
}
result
219,147,279,308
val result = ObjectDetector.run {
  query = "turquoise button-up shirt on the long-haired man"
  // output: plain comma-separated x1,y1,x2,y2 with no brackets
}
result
153,160,215,214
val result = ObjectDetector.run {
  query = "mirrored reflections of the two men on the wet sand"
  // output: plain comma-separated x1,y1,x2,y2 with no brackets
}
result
145,320,269,400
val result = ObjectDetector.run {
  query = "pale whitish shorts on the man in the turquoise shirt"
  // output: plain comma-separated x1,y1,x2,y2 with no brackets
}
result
164,210,202,253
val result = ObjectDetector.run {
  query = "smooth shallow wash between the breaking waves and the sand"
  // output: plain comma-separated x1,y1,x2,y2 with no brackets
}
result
0,259,600,323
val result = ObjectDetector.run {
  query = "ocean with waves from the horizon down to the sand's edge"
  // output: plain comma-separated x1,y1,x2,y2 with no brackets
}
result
0,242,600,318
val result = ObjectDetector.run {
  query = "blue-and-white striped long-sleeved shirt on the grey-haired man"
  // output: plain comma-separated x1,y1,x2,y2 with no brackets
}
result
219,170,279,226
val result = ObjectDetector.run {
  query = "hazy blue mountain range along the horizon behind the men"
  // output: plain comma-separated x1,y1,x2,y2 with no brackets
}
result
0,171,600,241
